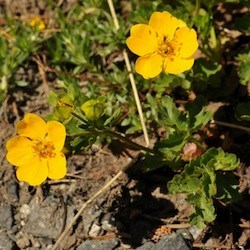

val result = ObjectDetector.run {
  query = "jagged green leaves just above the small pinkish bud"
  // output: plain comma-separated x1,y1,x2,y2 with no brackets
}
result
148,95,212,168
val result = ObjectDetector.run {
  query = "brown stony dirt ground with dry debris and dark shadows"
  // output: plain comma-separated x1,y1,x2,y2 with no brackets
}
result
0,0,250,250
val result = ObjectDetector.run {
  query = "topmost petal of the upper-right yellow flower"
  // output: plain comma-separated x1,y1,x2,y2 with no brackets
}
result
148,11,186,39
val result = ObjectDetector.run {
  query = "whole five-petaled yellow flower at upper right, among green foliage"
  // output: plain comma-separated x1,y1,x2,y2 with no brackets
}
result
126,11,198,79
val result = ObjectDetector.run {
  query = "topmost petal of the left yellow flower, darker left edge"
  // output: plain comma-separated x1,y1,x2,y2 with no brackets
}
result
16,113,47,139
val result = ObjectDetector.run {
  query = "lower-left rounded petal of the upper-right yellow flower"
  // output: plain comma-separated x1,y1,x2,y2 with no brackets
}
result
135,54,163,79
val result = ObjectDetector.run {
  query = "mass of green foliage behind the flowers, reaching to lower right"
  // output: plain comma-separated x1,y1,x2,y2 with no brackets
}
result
0,0,250,228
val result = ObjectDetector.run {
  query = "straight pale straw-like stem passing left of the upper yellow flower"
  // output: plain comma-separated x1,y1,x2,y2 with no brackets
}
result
107,0,149,147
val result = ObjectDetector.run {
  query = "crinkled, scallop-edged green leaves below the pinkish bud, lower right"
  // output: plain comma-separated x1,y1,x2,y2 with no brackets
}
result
168,148,239,228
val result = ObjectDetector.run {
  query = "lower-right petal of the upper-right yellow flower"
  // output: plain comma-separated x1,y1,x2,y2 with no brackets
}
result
164,57,194,74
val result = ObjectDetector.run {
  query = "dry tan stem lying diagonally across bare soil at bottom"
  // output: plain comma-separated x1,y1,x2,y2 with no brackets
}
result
52,170,123,250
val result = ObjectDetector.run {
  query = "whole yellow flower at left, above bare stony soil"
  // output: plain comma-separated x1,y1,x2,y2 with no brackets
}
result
6,114,66,186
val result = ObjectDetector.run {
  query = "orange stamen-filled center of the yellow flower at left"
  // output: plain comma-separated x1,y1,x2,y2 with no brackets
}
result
33,140,55,158
